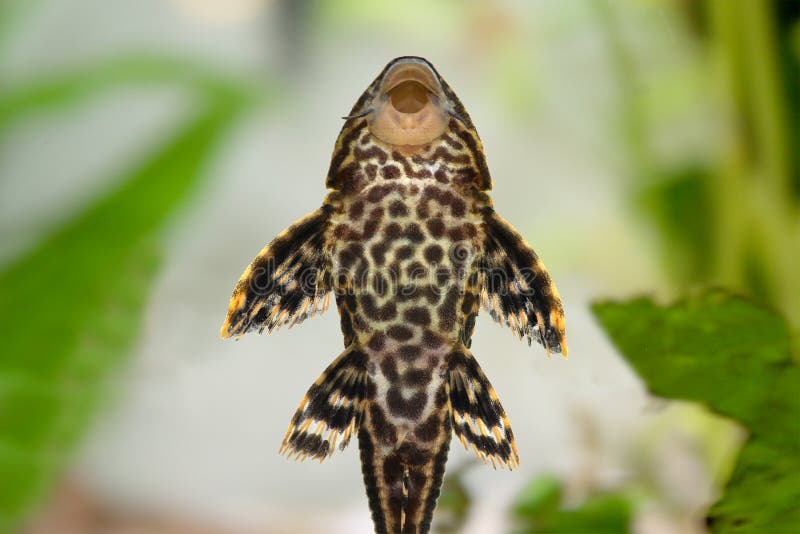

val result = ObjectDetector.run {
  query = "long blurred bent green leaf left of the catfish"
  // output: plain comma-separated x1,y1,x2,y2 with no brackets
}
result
0,56,266,530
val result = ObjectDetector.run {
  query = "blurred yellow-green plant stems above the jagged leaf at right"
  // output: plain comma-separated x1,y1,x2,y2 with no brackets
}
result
592,0,800,335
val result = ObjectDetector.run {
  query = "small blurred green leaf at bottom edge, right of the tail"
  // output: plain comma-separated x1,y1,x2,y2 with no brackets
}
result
514,476,632,534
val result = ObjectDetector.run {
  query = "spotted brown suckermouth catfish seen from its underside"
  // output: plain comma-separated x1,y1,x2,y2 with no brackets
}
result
221,56,567,534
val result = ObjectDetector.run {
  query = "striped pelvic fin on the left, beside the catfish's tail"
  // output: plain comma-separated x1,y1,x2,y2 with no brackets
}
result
278,348,367,461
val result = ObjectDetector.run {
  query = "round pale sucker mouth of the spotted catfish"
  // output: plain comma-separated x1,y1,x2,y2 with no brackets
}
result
368,59,448,146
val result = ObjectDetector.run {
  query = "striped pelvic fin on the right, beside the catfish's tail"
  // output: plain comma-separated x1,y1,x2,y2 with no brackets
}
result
448,350,519,469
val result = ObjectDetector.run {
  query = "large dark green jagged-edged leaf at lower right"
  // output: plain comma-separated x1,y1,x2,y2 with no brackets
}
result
593,291,800,532
